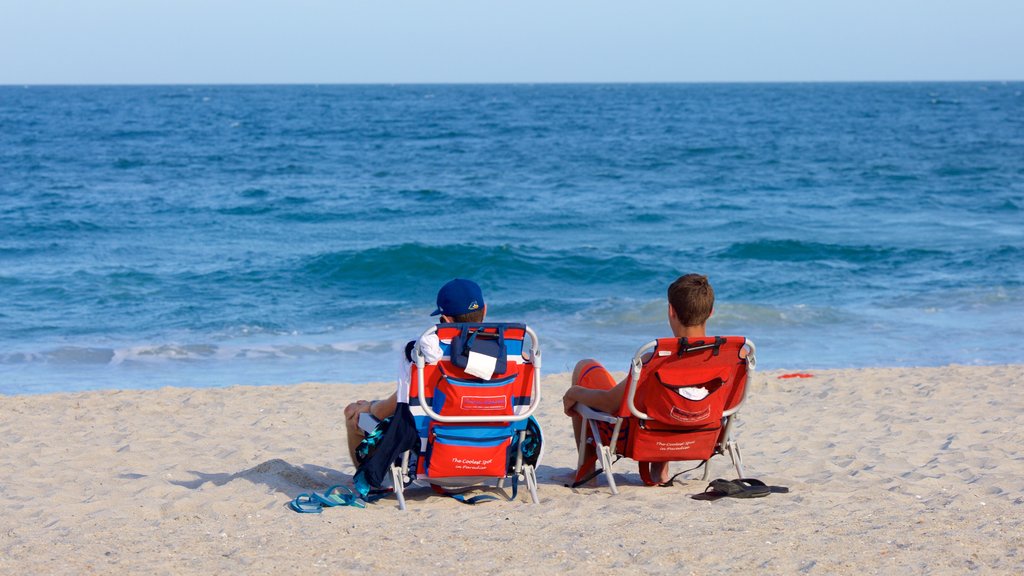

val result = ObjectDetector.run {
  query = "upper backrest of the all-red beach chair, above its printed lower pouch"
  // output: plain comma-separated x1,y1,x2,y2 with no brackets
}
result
620,336,754,429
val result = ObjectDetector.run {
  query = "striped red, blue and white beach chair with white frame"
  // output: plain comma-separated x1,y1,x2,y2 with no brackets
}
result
360,323,543,509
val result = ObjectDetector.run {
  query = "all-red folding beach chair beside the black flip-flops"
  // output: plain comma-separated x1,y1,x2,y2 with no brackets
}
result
573,336,756,494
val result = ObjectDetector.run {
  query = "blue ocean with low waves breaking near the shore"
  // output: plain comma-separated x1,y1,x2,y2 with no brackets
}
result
0,82,1024,395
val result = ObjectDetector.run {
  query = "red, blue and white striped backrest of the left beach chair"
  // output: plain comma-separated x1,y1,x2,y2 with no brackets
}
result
409,323,541,478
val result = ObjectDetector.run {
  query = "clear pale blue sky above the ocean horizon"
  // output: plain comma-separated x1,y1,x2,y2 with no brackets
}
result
0,0,1024,85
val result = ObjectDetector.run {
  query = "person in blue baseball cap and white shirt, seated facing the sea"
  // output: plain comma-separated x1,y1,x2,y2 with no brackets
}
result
345,278,487,464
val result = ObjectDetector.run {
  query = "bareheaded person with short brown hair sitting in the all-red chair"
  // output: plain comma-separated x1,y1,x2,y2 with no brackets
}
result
562,274,715,483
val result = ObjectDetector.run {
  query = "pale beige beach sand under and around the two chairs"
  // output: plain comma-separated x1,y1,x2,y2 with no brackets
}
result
0,366,1024,574
